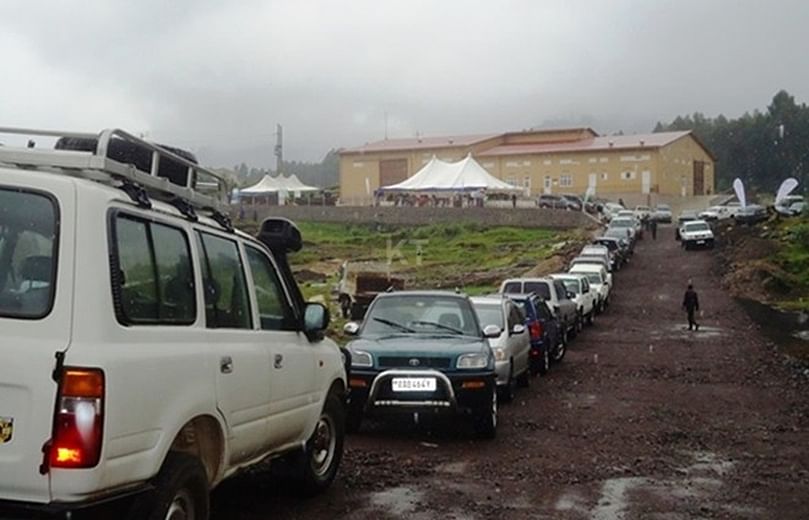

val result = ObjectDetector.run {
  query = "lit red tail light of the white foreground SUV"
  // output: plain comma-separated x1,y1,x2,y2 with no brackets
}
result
49,367,104,468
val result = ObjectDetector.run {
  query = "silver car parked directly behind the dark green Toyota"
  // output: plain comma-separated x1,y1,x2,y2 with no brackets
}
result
470,295,531,402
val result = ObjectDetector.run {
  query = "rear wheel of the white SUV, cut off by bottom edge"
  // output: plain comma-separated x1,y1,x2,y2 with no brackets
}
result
128,451,210,520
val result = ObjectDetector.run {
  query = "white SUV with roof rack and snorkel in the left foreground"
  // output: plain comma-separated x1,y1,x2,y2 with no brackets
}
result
0,129,346,519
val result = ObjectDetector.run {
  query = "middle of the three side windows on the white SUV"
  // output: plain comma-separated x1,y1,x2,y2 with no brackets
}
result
197,231,253,329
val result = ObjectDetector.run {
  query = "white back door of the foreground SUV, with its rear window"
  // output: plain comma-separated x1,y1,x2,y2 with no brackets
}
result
0,176,76,503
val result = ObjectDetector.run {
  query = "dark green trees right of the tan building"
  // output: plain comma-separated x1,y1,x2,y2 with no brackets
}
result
654,90,809,193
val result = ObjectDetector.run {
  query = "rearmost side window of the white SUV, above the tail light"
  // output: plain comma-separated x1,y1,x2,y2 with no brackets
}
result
112,213,197,325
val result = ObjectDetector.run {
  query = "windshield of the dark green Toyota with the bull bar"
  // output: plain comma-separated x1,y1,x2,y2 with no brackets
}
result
363,294,480,336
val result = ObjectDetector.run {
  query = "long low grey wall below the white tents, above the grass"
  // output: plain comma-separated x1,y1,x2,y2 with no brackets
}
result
248,206,594,229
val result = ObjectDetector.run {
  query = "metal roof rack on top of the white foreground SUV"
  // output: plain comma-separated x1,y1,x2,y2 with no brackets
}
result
0,127,228,212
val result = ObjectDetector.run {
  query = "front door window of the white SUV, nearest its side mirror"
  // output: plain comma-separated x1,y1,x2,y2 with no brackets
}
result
245,247,296,330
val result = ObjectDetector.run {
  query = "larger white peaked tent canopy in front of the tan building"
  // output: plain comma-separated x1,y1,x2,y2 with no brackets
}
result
380,154,523,192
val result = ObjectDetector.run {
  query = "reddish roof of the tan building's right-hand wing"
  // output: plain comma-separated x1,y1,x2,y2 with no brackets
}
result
478,131,696,157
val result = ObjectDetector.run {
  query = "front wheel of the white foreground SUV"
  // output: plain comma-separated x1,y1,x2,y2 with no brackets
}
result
289,392,345,496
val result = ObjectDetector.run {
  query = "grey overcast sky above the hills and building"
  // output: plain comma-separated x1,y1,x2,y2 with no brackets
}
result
0,0,809,166
